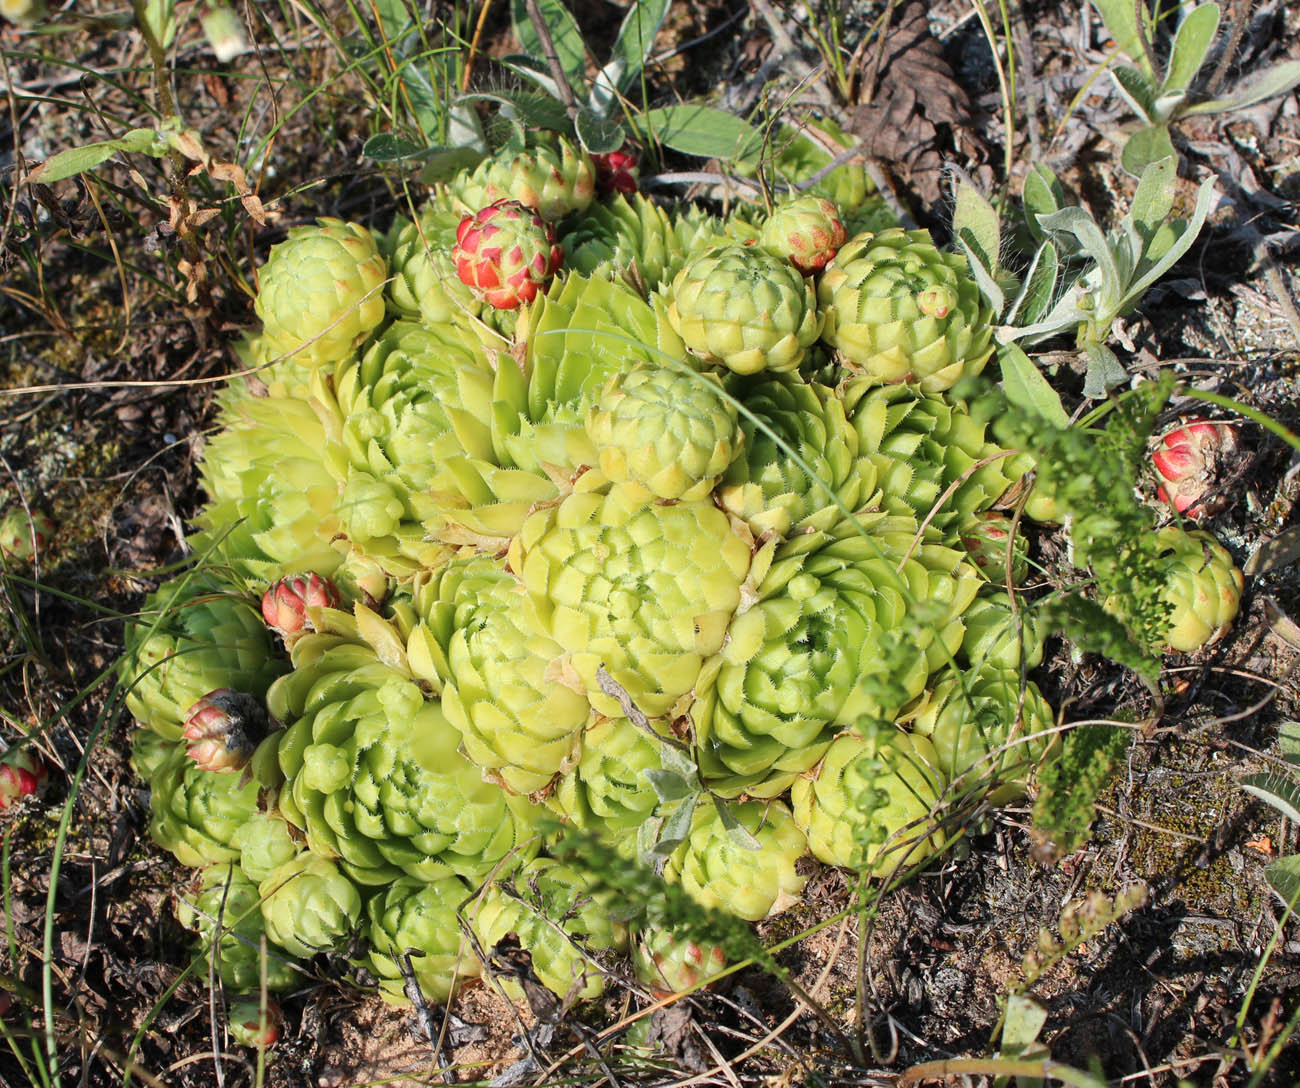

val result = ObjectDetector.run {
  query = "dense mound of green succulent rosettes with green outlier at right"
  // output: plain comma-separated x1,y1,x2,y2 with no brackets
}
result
121,139,1239,1002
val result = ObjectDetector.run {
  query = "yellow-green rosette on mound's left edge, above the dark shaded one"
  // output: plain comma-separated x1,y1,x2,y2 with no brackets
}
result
190,382,343,589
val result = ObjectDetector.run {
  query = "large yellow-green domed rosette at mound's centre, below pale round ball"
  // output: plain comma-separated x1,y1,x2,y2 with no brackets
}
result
510,489,750,718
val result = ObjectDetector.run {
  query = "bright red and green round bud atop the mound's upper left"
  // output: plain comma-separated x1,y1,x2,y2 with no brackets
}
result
451,200,564,309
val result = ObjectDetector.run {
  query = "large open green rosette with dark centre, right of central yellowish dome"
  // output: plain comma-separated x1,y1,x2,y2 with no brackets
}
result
690,519,978,797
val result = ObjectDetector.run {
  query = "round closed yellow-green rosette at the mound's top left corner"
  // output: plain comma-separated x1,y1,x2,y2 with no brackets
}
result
254,218,389,367
